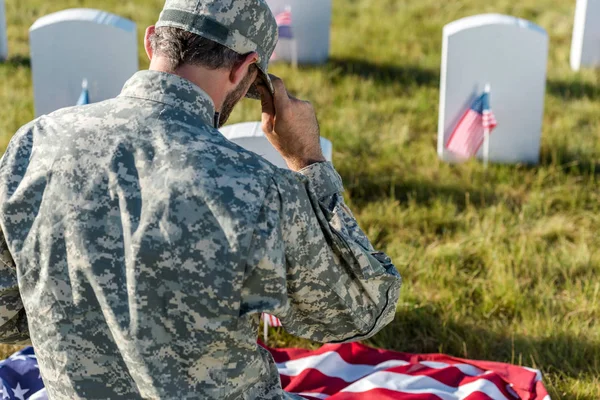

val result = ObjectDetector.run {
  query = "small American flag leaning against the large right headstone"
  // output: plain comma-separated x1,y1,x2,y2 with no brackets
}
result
446,91,498,158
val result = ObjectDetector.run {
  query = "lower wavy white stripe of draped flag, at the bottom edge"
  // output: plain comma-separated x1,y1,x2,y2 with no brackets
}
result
342,372,508,400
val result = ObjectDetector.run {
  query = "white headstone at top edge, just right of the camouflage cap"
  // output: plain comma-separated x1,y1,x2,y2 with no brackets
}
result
267,0,331,64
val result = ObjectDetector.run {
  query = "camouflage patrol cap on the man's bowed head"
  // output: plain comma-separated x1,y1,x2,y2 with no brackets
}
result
156,0,278,99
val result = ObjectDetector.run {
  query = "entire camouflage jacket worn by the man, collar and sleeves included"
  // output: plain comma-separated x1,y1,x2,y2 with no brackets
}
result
0,71,401,399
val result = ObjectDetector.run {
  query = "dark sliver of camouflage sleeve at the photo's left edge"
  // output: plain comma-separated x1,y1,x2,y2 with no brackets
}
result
0,231,29,344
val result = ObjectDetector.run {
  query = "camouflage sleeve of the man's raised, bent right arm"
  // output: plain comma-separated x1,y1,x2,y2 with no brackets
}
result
242,163,402,342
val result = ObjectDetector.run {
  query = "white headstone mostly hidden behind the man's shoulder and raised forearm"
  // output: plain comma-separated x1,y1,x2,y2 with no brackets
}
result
221,122,333,169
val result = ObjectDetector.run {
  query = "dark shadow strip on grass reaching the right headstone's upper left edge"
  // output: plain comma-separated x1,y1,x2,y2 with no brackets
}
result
327,58,440,87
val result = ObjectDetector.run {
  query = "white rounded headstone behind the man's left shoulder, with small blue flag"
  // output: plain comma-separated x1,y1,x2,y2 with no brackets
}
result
29,9,138,116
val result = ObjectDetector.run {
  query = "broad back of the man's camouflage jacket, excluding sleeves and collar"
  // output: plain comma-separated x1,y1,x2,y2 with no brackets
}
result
1,70,290,398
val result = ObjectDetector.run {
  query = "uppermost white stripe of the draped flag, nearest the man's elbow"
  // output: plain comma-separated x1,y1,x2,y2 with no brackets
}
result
277,351,410,382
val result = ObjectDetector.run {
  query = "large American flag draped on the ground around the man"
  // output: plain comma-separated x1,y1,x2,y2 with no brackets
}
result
0,343,550,400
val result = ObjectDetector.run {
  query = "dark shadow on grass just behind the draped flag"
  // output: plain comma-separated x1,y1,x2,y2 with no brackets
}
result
368,307,600,400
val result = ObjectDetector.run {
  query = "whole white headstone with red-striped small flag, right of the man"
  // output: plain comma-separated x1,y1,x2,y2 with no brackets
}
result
438,14,548,164
